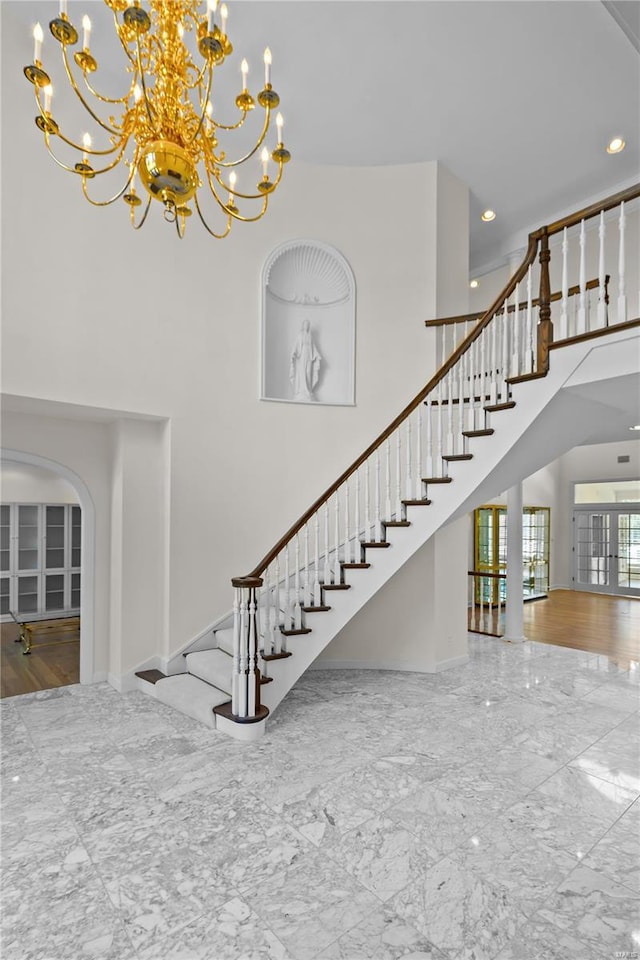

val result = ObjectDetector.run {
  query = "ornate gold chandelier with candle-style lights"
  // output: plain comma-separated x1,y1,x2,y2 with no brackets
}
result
24,0,291,239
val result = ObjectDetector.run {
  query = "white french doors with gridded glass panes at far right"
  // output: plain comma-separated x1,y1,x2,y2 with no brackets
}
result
573,507,640,596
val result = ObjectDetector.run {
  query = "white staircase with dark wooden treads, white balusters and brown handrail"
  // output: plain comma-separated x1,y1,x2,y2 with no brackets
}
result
138,184,640,739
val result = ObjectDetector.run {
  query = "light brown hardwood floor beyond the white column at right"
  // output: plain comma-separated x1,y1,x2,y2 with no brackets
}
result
472,590,640,669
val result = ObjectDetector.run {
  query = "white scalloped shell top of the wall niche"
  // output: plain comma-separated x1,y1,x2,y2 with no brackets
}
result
265,240,353,307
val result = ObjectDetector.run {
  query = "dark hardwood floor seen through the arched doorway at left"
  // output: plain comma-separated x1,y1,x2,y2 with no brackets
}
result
0,620,80,697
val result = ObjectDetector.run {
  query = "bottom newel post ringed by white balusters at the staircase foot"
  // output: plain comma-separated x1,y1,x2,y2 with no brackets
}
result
231,577,268,721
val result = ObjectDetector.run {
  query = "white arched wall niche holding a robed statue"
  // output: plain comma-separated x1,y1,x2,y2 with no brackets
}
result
260,240,356,405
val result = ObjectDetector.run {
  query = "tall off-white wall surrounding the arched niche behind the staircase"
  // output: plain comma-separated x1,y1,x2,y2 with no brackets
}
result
2,11,476,673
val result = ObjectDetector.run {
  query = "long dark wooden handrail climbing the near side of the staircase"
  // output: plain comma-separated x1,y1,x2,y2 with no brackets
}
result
232,184,640,587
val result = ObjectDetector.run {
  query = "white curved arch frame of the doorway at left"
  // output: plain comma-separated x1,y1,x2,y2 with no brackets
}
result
0,448,96,683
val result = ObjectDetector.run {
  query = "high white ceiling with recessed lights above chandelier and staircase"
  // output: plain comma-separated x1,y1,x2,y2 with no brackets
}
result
2,0,640,274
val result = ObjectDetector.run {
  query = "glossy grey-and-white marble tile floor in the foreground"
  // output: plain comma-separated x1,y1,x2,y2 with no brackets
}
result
0,636,640,960
